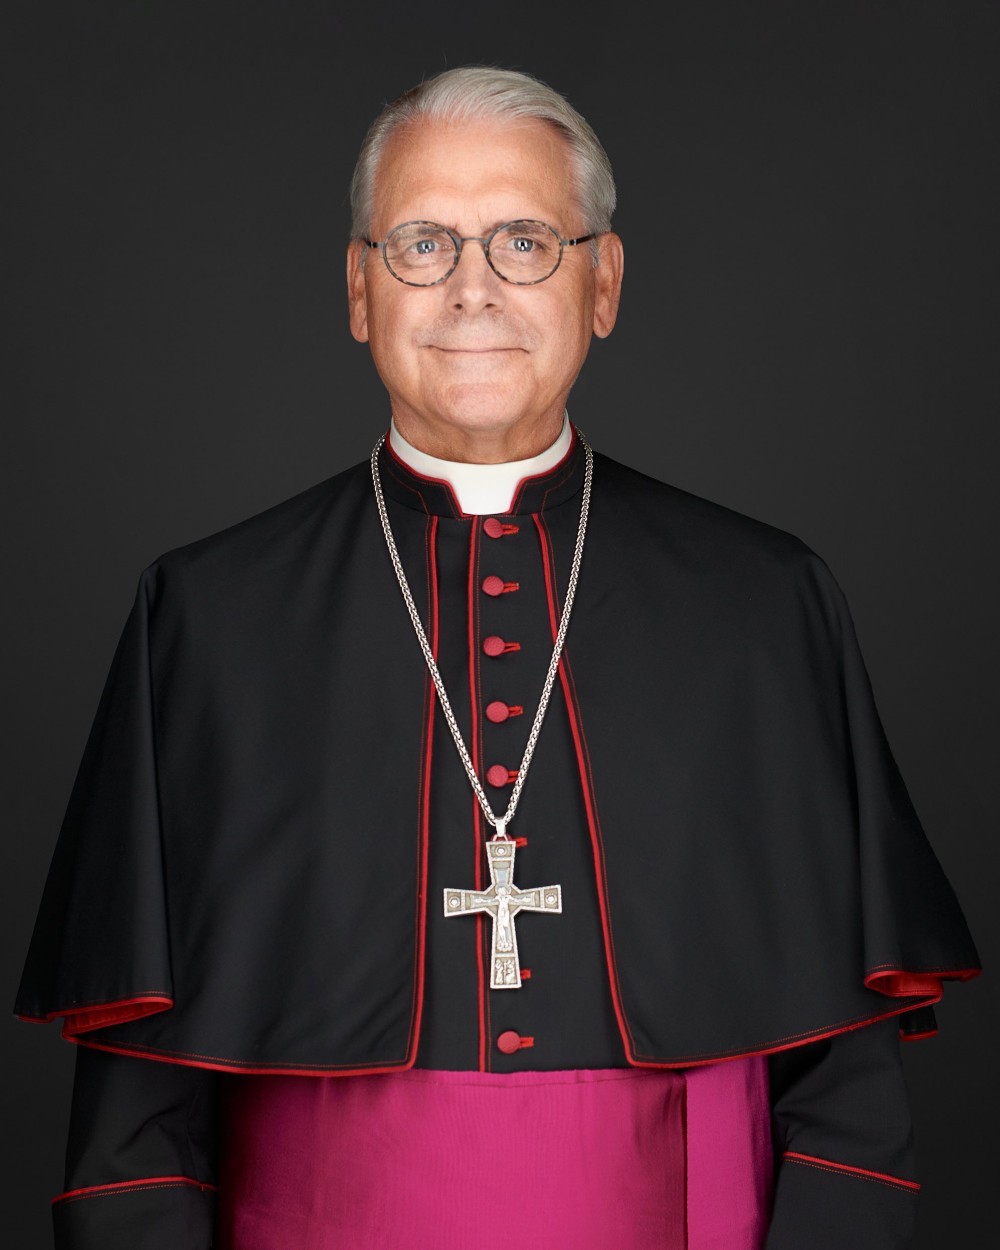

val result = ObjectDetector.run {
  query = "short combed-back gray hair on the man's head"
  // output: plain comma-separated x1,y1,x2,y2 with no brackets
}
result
351,65,616,239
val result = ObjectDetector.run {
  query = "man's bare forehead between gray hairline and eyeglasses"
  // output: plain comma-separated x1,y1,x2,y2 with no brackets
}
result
373,118,580,238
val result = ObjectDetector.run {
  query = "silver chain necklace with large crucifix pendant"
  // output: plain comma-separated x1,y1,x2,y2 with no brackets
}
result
371,430,594,990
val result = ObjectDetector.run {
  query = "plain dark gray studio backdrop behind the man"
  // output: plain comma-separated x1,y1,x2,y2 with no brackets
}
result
0,0,1000,1248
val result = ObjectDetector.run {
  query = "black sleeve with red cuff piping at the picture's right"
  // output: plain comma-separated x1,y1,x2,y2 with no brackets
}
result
766,1019,920,1250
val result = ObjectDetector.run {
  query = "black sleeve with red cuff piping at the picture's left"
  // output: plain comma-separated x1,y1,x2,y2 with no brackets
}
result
53,1046,224,1250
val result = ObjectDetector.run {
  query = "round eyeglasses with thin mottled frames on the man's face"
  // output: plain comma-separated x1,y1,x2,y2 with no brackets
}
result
363,219,598,286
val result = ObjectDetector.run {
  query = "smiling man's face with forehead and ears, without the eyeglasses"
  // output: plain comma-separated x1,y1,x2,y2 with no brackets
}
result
348,119,621,455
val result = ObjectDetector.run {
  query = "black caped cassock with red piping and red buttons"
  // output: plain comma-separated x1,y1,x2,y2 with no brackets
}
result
16,436,979,1250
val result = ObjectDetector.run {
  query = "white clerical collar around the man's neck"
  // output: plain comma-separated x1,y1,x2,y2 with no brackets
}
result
386,415,579,516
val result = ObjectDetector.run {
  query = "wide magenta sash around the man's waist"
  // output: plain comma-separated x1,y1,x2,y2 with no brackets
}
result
219,1059,771,1250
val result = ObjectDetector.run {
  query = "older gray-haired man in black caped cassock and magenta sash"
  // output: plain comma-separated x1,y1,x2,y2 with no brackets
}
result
19,69,978,1250
